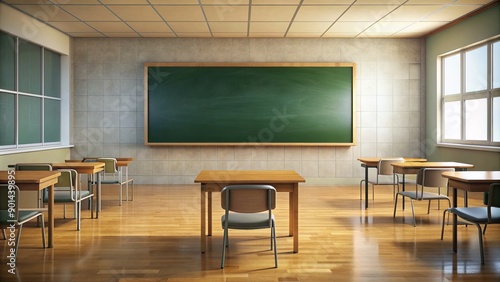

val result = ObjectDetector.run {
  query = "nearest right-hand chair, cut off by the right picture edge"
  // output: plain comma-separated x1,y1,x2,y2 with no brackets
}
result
441,183,500,264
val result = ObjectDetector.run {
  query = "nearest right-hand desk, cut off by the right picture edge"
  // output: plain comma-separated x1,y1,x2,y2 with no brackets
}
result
443,171,500,253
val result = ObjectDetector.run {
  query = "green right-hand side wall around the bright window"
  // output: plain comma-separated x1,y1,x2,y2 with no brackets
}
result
425,3,500,170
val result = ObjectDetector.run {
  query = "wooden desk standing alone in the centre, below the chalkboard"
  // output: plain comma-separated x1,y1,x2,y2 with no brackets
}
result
194,170,305,253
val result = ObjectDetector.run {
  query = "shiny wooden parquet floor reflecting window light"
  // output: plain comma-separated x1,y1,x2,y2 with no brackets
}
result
0,185,500,282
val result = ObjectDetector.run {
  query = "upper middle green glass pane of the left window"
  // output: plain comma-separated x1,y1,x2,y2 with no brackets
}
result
19,40,42,94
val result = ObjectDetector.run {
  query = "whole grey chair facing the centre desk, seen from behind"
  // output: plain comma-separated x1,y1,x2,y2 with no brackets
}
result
221,185,278,268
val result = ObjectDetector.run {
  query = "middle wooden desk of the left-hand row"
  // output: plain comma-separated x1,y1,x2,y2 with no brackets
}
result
56,161,104,218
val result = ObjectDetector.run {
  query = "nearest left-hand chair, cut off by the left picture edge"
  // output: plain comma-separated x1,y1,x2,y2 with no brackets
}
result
0,184,45,257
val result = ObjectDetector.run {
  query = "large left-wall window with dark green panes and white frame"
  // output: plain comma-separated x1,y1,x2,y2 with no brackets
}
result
0,32,61,149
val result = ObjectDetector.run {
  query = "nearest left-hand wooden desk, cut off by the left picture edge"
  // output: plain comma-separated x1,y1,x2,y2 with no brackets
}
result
0,170,61,248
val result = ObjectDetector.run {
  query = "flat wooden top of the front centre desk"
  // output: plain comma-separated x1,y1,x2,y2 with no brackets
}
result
194,170,305,183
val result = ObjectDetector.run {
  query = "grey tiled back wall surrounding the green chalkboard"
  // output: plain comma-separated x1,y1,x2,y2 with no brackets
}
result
71,38,424,184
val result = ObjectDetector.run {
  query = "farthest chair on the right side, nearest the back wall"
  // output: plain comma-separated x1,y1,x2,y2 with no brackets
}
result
359,158,405,200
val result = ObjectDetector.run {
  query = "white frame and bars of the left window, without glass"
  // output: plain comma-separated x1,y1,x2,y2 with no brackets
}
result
0,30,64,150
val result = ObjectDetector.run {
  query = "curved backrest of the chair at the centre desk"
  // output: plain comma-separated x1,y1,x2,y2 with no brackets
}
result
221,184,276,213
